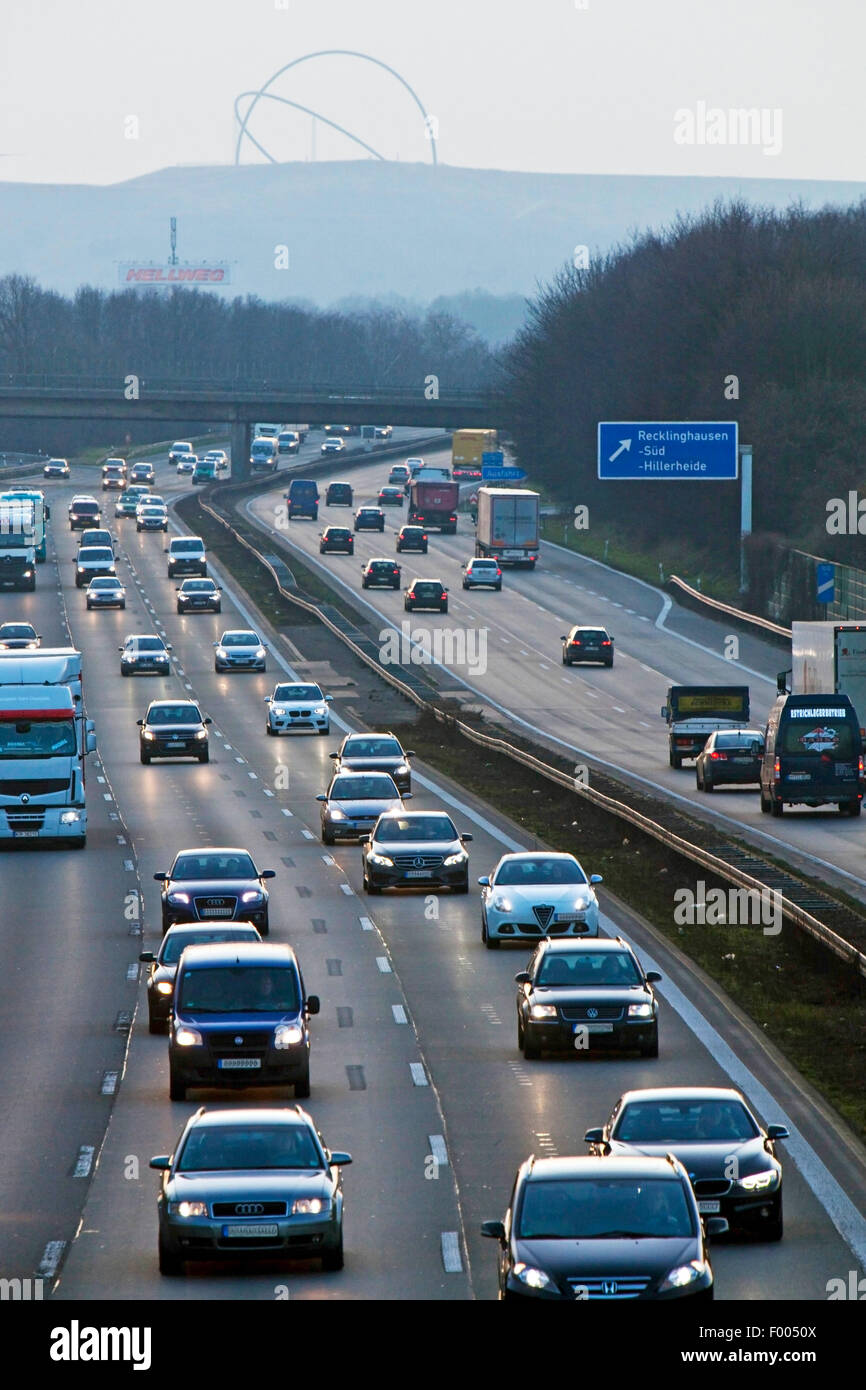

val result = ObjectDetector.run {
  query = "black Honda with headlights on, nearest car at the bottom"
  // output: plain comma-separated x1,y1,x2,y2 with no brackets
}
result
481,1154,728,1302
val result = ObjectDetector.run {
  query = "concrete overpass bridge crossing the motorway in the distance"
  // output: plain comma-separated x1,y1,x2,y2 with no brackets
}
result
0,373,507,477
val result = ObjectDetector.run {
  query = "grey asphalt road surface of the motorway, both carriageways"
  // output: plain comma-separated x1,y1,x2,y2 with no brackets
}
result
0,439,866,1301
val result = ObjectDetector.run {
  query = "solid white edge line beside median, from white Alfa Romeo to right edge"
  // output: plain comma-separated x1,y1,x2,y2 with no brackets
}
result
599,913,866,1266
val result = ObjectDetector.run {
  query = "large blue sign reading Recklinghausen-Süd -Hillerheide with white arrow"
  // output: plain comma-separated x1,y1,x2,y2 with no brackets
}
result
598,420,738,482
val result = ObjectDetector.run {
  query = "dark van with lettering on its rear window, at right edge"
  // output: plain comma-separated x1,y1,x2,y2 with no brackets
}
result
760,694,865,816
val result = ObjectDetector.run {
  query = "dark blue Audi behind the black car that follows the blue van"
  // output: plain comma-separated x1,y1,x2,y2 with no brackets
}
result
153,848,277,937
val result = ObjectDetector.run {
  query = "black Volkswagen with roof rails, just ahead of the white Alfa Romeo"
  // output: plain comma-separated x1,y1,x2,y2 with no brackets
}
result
514,937,662,1058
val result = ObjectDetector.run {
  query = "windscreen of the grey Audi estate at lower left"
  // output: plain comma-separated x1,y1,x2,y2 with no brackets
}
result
178,1123,324,1173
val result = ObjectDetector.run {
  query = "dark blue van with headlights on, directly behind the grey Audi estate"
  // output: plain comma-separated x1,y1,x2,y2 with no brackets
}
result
168,941,320,1101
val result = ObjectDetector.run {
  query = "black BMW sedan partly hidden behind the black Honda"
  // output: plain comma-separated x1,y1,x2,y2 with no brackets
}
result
584,1086,788,1240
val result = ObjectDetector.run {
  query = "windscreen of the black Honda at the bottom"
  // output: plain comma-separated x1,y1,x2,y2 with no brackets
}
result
517,1177,694,1240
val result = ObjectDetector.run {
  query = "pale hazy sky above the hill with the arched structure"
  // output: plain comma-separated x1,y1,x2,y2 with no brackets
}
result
0,0,866,183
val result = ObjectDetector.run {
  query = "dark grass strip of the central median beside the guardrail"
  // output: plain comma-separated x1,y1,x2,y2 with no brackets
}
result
179,498,866,1140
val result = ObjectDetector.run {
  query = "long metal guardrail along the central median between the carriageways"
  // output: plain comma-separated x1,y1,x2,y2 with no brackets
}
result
199,483,866,977
